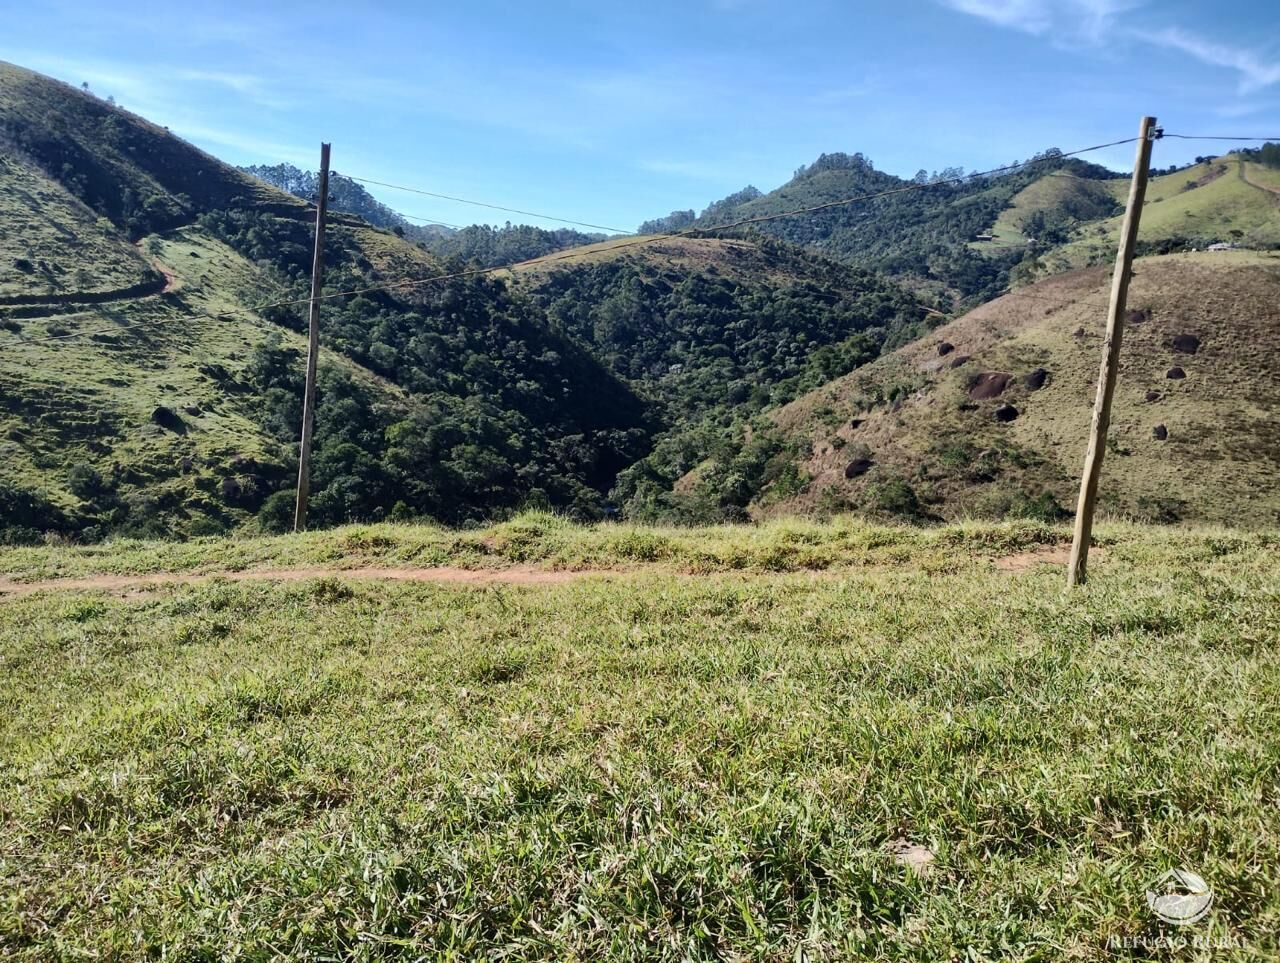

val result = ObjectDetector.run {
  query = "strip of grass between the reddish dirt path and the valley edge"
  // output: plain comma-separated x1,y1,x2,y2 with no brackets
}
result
0,512,1070,581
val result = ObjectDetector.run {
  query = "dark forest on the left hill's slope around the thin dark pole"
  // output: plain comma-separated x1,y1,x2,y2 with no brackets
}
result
201,210,653,522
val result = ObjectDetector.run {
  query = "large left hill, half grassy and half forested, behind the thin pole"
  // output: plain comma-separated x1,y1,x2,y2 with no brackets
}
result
0,65,650,538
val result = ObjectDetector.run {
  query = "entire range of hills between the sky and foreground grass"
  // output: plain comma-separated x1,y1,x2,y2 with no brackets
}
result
0,64,1280,540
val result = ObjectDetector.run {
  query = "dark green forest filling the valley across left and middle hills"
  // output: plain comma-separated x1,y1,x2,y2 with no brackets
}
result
201,210,928,526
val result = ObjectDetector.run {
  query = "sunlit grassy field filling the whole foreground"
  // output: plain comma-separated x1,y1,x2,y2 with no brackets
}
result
0,516,1280,960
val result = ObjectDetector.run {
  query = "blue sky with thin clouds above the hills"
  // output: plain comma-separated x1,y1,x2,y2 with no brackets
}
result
0,0,1280,229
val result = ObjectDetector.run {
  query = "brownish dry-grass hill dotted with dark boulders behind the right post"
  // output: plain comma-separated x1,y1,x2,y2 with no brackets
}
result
755,251,1280,526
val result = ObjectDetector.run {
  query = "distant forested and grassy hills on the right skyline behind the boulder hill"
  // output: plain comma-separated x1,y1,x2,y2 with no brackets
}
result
641,142,1280,307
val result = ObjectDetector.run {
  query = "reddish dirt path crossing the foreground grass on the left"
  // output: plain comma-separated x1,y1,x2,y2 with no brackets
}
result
0,566,599,598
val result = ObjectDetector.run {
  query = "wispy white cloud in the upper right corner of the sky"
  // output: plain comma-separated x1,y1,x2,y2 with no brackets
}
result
940,0,1280,95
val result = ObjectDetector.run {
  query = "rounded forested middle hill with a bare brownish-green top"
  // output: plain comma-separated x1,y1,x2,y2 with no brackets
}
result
513,236,929,414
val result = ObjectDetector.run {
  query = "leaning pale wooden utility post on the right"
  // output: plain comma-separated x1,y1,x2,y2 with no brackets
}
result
1066,117,1156,588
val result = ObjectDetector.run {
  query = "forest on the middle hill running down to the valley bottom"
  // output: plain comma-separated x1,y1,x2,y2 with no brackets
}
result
517,234,932,521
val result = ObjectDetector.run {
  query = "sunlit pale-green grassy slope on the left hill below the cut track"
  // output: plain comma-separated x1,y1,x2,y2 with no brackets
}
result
0,227,402,533
